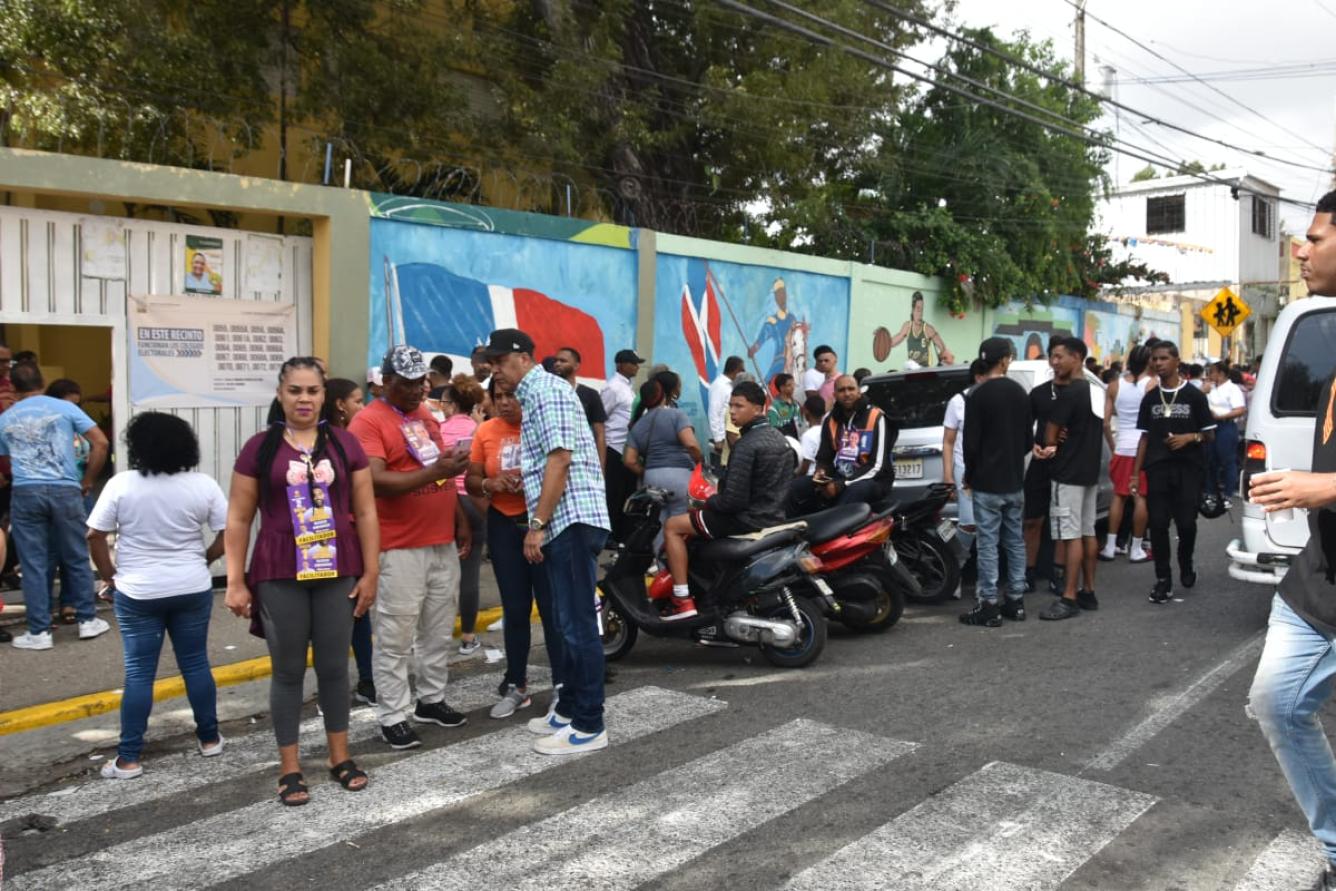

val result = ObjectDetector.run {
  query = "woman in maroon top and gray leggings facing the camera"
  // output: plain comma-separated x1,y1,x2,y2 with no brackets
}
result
224,357,381,806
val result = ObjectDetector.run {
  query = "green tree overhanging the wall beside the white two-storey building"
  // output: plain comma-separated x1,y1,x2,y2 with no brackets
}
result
810,29,1149,310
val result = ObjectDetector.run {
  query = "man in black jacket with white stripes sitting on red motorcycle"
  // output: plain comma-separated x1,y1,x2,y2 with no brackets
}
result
788,374,899,517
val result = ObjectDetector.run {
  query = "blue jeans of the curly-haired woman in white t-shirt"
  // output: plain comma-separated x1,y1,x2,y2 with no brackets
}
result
115,590,218,763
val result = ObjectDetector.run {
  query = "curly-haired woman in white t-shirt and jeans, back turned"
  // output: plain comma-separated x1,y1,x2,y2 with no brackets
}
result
88,411,227,780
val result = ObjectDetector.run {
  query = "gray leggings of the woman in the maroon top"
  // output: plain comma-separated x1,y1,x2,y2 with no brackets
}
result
255,576,357,747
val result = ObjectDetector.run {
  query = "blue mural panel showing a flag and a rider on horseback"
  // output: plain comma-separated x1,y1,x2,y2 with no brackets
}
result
653,254,850,434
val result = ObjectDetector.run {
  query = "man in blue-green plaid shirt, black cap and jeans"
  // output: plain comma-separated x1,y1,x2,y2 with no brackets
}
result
488,329,611,755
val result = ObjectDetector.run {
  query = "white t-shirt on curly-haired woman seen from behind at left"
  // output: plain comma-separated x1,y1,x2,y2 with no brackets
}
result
88,470,227,600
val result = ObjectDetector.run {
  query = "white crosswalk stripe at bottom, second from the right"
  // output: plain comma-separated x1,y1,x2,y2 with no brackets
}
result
786,761,1156,891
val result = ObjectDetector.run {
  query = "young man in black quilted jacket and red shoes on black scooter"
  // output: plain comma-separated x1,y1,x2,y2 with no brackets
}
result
664,378,790,621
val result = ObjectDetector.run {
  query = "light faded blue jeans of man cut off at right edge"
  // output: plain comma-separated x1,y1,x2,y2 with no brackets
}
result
1248,595,1336,862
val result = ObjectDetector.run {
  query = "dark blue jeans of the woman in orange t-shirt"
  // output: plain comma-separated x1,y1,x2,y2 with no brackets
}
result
488,508,564,689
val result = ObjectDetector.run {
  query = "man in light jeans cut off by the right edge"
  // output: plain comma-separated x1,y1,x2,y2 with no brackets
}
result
1245,191,1336,888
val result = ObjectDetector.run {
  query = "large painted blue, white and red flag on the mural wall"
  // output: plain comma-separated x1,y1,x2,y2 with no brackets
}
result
385,258,608,386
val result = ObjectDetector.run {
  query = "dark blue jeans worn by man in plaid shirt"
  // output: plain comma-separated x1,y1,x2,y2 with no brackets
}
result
539,522,608,733
